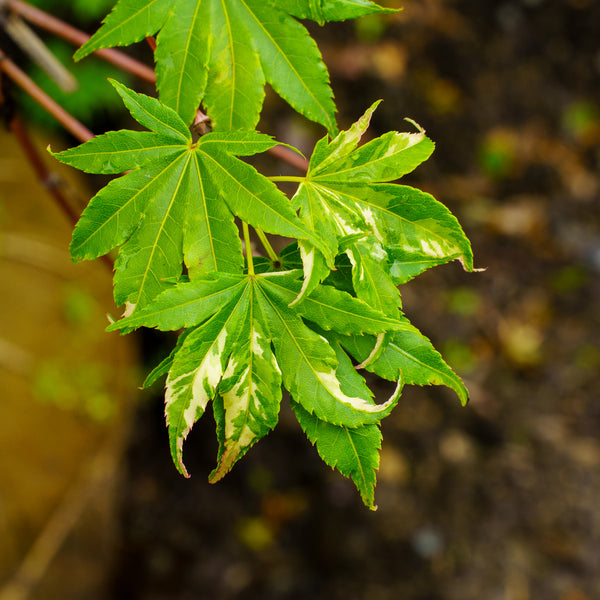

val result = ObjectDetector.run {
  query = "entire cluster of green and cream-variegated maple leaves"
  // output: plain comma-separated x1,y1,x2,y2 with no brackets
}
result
54,0,473,508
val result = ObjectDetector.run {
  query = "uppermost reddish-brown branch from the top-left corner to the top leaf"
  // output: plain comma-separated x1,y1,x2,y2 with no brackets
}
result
1,0,156,83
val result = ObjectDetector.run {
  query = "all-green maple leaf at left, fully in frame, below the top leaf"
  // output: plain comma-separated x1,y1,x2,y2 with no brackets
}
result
55,82,327,308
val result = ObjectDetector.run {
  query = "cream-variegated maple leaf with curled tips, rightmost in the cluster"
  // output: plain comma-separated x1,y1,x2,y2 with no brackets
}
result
294,103,473,315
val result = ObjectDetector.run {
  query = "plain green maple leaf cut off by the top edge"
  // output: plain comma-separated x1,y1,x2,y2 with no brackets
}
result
75,0,389,133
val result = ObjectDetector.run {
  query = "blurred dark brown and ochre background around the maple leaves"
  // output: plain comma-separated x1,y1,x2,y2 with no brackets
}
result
0,0,600,600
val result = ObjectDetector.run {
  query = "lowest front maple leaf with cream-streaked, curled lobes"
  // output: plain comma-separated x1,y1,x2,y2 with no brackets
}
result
108,271,404,488
